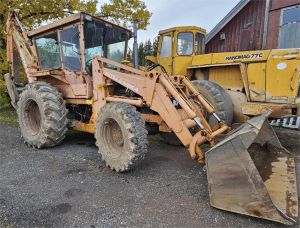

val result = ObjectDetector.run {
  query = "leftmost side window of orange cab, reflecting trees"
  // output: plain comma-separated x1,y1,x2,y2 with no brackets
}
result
35,32,61,69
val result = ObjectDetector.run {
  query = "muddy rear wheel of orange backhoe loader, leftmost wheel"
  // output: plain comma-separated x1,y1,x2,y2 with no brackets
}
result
17,82,68,148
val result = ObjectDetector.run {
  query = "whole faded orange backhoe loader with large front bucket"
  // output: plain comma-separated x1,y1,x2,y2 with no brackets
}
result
4,10,298,224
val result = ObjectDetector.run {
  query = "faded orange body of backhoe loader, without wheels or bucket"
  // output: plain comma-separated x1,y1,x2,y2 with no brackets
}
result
7,10,229,160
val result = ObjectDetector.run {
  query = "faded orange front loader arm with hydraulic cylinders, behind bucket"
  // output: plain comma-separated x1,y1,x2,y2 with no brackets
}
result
92,57,229,163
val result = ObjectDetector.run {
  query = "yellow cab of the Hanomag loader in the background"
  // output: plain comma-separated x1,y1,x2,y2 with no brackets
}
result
155,26,206,75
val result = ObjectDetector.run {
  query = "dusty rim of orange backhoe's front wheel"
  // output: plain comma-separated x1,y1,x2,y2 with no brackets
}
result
104,119,124,158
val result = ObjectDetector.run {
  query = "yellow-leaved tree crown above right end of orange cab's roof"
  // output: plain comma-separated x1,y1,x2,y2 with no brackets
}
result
100,0,152,29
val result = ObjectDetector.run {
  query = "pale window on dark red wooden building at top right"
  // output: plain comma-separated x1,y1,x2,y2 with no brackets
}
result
279,5,300,48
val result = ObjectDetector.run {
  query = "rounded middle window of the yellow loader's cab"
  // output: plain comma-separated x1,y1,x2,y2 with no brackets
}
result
177,32,194,55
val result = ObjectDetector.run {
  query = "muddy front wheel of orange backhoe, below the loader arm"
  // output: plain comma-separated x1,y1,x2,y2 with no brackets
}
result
95,102,148,172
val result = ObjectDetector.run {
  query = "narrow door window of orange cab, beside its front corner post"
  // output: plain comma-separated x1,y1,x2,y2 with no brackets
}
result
60,26,81,71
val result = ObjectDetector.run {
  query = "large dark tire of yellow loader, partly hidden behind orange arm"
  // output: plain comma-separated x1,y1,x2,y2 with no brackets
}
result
192,80,233,126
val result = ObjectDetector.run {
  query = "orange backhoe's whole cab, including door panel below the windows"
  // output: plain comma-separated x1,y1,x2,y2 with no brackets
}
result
28,13,132,98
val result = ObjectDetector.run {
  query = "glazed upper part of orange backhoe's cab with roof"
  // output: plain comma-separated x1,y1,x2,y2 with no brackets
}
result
28,13,132,73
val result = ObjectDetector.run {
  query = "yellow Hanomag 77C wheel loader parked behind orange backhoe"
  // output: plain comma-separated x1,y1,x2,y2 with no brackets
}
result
146,26,300,124
